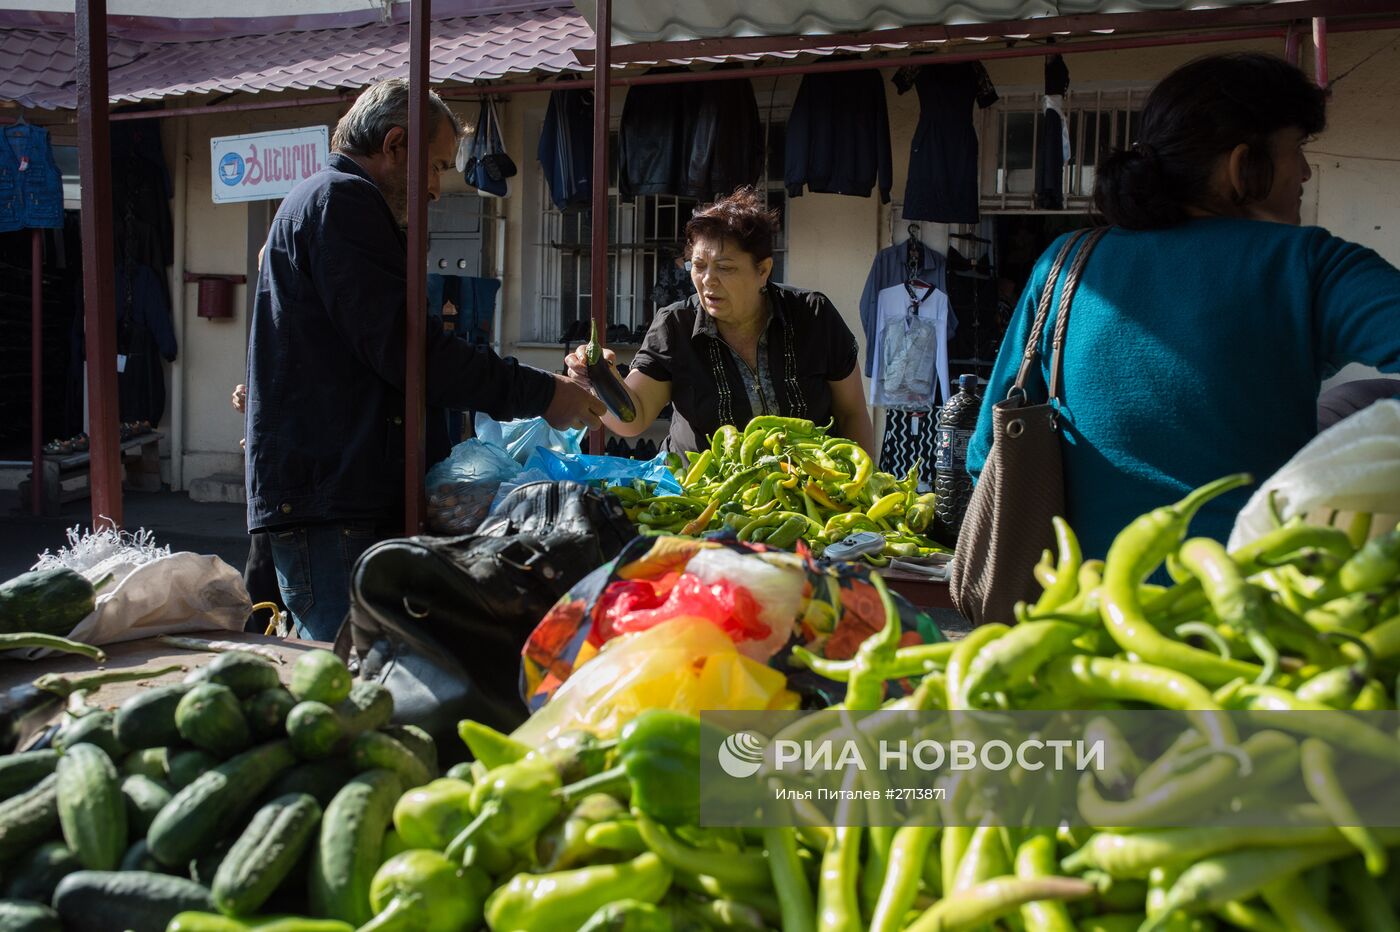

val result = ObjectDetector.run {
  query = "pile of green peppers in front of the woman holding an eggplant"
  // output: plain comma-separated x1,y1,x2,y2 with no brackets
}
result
610,416,946,565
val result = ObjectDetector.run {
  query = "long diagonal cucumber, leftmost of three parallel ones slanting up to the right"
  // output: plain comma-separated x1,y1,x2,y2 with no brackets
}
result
146,742,295,868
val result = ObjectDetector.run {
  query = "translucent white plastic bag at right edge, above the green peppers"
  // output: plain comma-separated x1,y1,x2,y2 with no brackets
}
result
1229,399,1400,550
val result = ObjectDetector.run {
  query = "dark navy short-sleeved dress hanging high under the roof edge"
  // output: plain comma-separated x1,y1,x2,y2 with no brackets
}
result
895,62,997,224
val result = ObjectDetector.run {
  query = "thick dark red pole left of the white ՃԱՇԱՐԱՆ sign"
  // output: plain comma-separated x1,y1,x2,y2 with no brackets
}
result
74,0,122,528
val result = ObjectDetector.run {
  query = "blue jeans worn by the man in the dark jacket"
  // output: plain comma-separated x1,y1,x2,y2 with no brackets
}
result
266,523,384,641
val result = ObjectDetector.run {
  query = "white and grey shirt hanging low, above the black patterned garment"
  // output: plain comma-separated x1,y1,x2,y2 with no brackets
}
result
871,283,949,407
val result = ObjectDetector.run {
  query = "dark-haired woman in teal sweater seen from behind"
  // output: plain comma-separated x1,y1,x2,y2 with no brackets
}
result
967,55,1400,557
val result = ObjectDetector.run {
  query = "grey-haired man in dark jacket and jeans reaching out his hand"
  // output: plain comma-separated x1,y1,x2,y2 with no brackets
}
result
245,78,605,641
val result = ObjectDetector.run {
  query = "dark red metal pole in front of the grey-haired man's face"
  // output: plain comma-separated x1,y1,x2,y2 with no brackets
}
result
403,0,433,536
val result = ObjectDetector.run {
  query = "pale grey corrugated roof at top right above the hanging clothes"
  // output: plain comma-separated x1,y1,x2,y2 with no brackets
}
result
574,0,1289,45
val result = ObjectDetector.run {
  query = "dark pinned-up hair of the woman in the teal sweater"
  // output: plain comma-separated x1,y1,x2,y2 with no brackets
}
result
1093,52,1327,230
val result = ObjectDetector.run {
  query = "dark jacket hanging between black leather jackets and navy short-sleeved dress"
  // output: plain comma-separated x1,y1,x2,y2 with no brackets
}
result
783,70,893,204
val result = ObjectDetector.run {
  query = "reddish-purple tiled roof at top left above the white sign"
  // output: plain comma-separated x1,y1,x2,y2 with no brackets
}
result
0,7,594,109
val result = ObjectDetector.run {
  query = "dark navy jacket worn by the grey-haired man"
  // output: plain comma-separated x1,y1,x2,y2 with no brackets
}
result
244,153,554,530
